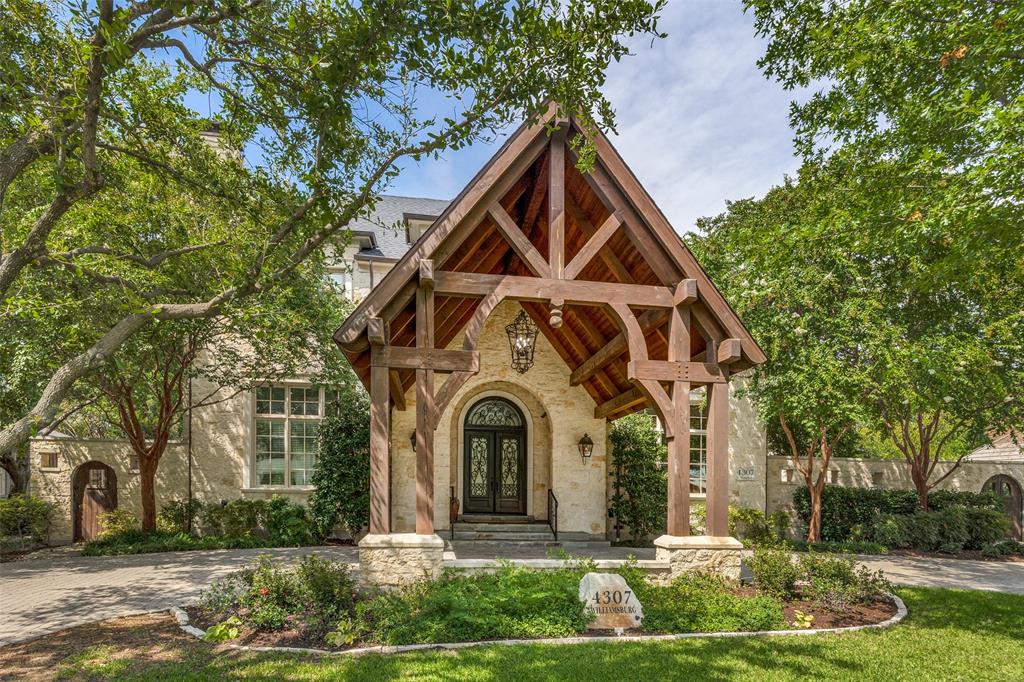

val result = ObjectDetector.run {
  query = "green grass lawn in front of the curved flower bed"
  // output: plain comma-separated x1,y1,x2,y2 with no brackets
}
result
57,589,1024,682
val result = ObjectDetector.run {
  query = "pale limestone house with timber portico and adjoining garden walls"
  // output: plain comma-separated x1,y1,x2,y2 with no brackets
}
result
24,112,1024,543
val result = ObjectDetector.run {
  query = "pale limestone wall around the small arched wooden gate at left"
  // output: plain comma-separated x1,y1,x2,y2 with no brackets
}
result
29,438,188,544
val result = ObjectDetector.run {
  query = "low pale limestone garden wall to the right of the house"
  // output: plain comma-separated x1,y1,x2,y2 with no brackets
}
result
766,456,1024,532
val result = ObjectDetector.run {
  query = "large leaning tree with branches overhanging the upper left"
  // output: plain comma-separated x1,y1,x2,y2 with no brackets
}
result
0,0,662,453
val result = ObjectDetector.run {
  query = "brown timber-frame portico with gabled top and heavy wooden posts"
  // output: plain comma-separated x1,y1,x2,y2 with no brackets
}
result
335,100,765,537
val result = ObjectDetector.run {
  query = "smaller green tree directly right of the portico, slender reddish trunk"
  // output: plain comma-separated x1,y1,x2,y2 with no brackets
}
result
691,169,878,542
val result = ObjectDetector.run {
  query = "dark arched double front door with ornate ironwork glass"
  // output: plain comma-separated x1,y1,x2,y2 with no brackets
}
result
463,397,526,514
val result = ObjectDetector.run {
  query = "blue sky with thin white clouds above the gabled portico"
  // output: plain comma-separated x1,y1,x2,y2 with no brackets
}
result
389,0,799,232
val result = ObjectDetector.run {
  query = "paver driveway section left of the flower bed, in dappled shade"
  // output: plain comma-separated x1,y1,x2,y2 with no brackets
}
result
0,547,357,646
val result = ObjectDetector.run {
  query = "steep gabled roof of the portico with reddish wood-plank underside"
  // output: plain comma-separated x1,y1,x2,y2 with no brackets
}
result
335,105,765,416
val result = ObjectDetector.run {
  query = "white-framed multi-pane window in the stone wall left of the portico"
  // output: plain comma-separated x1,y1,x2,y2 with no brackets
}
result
255,386,333,487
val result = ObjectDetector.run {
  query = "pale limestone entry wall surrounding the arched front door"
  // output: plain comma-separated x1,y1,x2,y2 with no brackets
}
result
391,301,607,537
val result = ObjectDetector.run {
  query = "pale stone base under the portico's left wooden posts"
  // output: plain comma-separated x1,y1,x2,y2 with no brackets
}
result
359,532,444,588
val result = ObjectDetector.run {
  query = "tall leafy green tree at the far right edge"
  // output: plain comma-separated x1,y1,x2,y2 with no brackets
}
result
746,0,1024,509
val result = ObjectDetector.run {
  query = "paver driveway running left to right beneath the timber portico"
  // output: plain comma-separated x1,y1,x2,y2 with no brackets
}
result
0,547,1024,646
